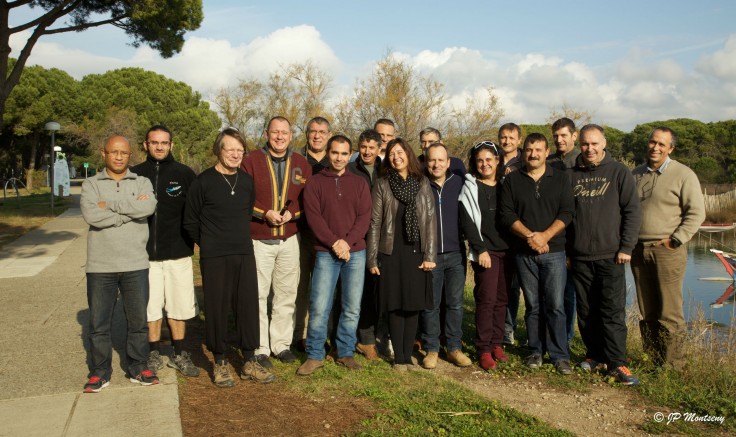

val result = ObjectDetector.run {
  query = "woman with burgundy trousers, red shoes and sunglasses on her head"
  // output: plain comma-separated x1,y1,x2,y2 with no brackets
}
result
460,141,513,370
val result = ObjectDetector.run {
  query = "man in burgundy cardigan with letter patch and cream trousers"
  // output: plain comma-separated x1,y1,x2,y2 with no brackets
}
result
242,116,312,369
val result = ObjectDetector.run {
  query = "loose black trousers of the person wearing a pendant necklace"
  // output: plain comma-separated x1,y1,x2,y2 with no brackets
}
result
199,254,260,356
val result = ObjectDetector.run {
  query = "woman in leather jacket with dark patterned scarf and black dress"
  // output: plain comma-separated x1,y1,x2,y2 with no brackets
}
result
367,138,437,371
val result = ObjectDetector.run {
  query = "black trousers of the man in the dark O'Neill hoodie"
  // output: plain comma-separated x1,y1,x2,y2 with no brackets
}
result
572,258,628,368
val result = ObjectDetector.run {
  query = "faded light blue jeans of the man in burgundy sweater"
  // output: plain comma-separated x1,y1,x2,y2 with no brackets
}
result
307,250,365,360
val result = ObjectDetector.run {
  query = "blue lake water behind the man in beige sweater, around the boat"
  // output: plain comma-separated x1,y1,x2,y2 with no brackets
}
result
626,231,736,326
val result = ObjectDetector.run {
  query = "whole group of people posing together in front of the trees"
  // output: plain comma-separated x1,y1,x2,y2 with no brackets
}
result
81,116,704,392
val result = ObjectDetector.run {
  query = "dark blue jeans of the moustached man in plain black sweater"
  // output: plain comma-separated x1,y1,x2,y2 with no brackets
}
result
516,252,570,363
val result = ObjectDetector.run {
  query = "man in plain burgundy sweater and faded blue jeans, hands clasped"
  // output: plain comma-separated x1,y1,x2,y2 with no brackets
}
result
297,135,371,376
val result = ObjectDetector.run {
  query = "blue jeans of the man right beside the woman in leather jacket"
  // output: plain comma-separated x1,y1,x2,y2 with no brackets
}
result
422,251,465,352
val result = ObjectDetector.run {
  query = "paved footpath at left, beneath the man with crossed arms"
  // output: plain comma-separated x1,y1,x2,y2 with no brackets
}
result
0,187,182,437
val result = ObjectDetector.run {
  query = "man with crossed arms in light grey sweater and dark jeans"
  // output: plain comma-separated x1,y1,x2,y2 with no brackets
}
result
80,135,158,393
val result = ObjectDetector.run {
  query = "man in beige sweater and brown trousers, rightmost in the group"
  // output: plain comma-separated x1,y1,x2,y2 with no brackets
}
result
631,127,705,369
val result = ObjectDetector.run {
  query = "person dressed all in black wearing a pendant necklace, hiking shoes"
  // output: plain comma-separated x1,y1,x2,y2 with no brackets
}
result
184,128,276,388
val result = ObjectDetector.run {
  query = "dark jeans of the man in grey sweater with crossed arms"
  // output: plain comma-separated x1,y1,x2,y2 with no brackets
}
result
87,269,149,381
